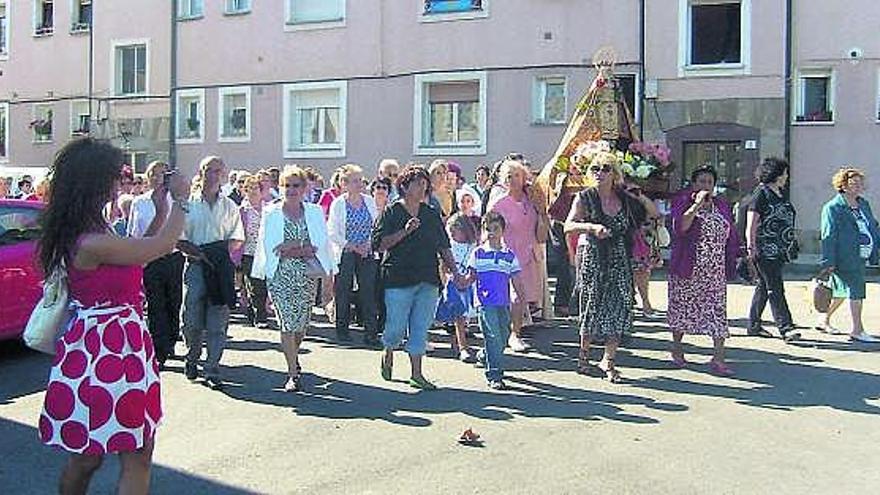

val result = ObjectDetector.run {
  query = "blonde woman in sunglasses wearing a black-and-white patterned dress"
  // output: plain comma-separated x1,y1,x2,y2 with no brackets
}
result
565,147,657,382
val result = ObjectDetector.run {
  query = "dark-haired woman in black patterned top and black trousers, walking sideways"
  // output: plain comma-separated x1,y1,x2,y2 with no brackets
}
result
746,158,800,342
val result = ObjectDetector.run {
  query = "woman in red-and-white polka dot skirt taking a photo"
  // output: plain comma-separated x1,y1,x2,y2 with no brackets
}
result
39,138,189,494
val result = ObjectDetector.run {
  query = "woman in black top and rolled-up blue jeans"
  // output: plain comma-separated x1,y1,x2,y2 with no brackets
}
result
373,165,462,390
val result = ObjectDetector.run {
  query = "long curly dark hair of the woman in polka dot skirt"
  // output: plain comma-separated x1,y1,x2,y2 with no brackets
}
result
39,138,123,275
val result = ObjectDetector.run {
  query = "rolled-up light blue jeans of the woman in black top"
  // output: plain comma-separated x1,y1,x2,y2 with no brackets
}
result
382,282,440,356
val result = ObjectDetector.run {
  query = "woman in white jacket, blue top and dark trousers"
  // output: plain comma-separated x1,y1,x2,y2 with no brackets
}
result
327,165,379,347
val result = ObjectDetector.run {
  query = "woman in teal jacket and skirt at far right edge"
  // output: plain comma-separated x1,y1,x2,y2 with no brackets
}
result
819,167,880,343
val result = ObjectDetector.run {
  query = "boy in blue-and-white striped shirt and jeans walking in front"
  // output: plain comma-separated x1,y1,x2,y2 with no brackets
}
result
467,211,525,390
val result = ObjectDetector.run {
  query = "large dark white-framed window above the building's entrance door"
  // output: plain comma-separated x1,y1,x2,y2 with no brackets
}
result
679,0,752,74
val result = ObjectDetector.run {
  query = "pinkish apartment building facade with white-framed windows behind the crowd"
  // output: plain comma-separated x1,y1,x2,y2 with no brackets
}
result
0,0,880,245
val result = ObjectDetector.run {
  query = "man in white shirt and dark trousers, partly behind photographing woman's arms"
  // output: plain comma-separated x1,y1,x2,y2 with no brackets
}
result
128,161,183,368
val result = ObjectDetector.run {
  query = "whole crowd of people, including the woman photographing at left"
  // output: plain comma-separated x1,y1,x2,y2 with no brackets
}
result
29,138,880,493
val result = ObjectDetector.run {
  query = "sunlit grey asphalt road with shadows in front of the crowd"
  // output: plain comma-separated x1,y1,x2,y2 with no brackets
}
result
0,282,880,495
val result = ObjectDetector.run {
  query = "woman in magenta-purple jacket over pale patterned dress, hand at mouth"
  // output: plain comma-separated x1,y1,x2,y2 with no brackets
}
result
668,167,740,375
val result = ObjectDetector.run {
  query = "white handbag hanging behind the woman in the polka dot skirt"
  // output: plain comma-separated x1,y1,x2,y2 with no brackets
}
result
23,264,73,355
